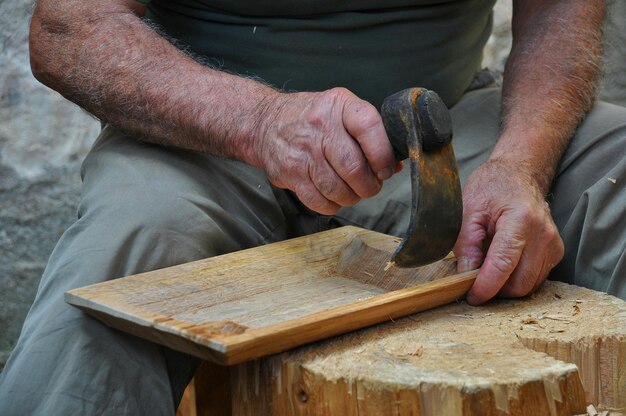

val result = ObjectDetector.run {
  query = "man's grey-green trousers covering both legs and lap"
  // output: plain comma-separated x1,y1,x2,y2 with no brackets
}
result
0,89,626,415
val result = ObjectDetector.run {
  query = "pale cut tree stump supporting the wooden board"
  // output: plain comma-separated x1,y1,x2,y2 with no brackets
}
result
201,282,626,416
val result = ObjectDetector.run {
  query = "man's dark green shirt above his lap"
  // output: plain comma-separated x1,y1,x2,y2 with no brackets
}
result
147,0,495,107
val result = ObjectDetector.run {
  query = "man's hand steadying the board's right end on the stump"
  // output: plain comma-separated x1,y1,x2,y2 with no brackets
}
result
454,160,563,305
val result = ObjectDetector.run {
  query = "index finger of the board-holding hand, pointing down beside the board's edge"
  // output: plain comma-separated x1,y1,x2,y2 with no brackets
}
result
467,224,526,305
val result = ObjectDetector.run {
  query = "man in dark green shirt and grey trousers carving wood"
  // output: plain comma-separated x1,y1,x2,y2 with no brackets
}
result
0,0,626,415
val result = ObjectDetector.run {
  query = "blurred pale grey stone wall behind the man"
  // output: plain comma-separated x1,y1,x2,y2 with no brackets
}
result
0,0,626,369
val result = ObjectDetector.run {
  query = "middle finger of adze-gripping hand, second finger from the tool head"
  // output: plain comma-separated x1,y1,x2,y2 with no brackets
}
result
323,134,382,198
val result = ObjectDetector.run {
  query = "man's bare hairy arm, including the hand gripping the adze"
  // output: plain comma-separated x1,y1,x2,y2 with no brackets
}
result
30,0,396,214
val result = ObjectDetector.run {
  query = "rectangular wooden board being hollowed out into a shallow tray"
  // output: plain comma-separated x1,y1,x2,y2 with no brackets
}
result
66,227,477,364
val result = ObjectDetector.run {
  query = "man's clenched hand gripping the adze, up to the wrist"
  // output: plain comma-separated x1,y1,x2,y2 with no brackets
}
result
252,88,399,214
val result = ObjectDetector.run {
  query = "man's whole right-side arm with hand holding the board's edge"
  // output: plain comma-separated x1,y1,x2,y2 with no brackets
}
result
455,0,604,304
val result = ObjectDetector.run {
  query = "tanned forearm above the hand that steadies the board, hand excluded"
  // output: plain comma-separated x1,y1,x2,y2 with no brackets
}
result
491,0,604,194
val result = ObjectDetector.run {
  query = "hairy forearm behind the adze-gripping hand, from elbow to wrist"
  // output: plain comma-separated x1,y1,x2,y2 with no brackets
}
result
31,0,276,164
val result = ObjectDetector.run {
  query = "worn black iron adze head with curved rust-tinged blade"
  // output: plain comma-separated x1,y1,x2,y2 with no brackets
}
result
381,88,463,267
